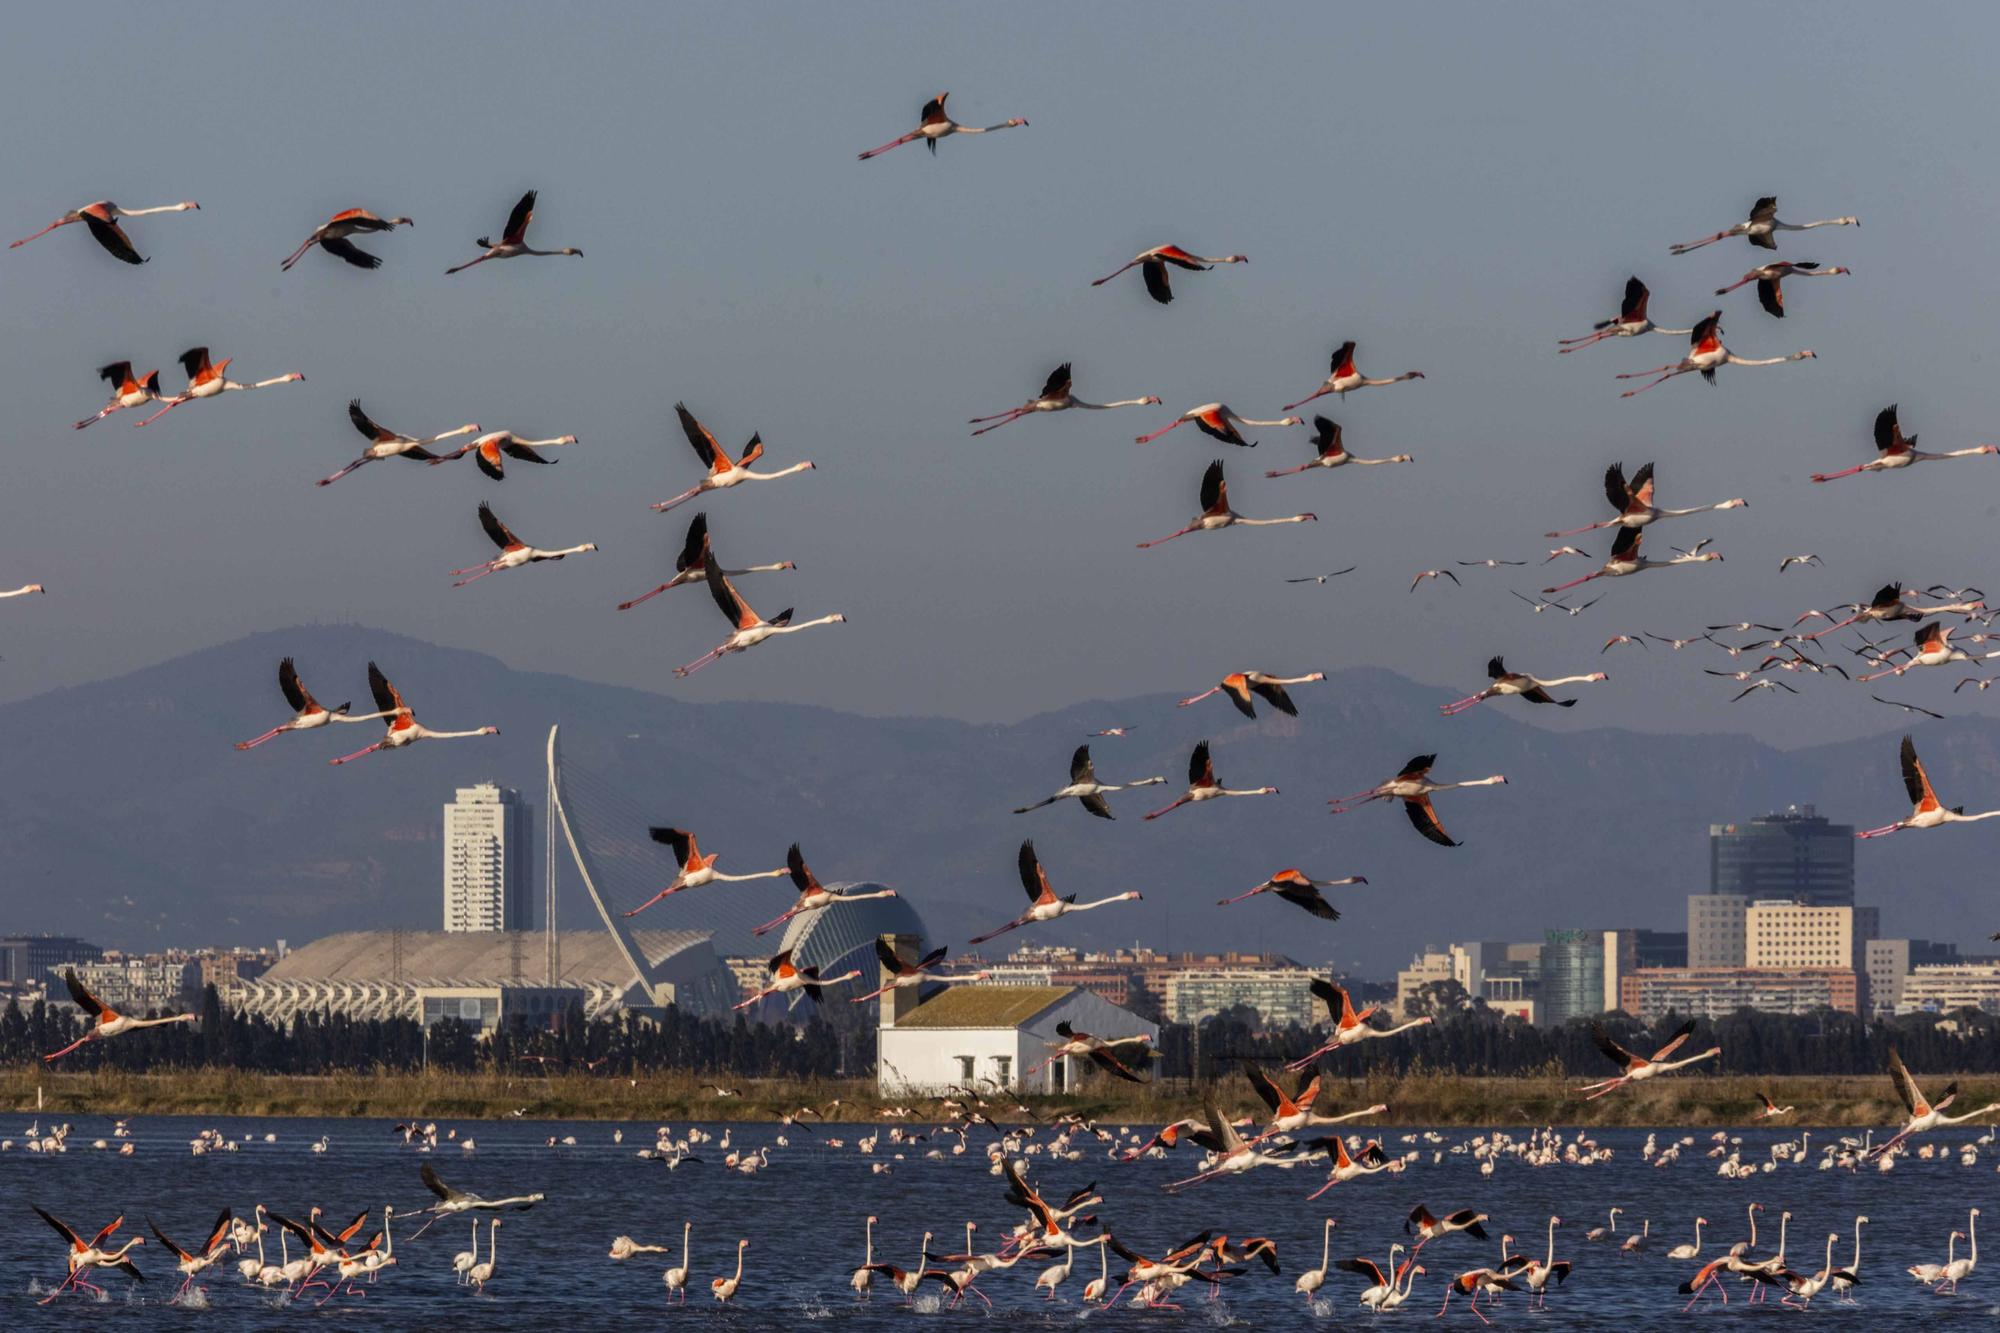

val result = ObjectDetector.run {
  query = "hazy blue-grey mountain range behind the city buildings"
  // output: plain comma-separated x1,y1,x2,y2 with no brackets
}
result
0,626,2000,964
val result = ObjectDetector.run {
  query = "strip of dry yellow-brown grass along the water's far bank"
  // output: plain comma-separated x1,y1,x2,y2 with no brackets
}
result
0,1067,2000,1137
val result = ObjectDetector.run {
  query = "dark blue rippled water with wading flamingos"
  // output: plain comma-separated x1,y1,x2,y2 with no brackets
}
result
0,1115,2000,1331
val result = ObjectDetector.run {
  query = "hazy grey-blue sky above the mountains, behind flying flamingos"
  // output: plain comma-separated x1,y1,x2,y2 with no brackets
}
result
0,2,2000,745
